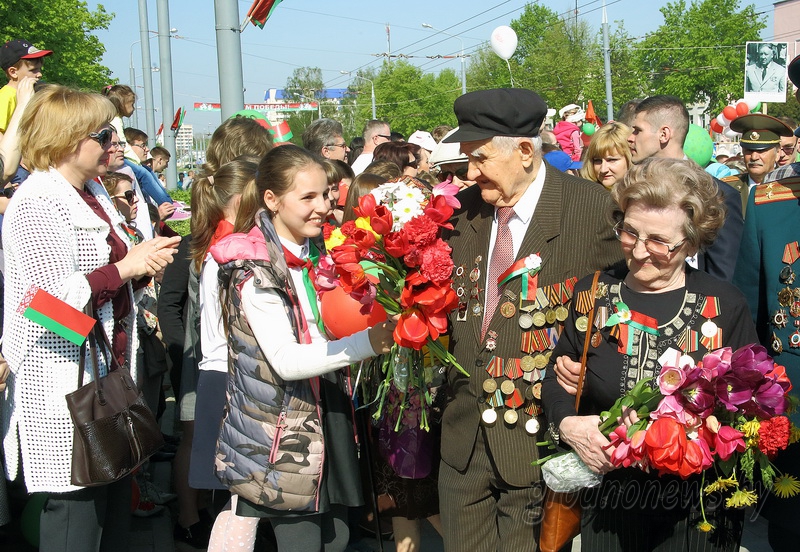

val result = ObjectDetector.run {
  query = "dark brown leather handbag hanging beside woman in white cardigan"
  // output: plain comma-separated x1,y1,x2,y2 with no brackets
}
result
66,316,164,487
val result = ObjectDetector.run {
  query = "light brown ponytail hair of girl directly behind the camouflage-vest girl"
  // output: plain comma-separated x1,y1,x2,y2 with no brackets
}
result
191,156,259,271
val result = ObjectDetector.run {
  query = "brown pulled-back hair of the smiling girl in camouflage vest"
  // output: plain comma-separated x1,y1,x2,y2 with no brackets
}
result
235,144,325,228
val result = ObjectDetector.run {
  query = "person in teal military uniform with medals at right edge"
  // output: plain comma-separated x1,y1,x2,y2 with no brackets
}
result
733,123,800,552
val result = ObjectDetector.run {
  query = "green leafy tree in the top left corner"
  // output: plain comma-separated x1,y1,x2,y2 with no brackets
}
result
0,0,114,90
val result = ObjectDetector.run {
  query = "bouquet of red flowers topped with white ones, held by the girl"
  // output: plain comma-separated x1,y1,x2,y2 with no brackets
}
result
321,178,466,430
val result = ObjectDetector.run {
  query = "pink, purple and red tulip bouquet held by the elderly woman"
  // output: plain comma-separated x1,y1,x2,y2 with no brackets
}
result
540,345,800,531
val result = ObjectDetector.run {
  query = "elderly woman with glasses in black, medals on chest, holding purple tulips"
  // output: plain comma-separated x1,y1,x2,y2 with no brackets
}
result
542,159,757,551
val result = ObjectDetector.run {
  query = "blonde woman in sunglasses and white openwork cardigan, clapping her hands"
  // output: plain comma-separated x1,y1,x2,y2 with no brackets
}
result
2,85,180,552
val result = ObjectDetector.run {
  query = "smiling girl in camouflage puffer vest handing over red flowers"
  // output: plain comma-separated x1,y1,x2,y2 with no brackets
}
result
208,145,395,551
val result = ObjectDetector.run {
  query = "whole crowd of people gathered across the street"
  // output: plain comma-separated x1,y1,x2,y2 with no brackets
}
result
0,33,800,552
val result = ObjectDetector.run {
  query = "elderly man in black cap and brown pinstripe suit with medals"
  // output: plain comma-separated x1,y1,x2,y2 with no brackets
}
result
439,89,621,552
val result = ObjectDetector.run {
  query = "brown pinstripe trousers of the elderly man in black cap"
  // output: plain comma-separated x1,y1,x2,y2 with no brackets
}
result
439,428,543,552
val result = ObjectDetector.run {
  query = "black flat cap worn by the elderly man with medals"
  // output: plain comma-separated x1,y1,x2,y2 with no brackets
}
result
443,88,547,142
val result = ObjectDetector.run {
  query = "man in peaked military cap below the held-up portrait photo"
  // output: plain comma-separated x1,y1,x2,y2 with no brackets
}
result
722,113,792,214
